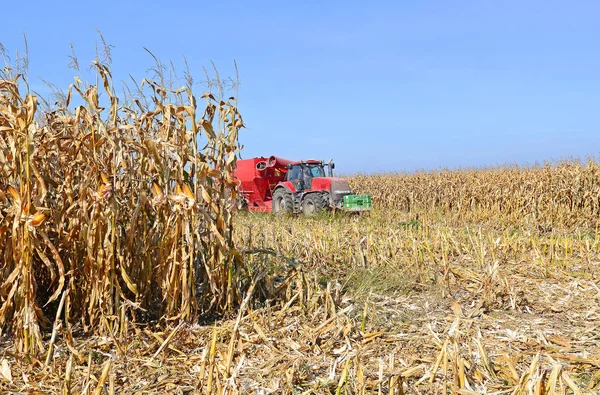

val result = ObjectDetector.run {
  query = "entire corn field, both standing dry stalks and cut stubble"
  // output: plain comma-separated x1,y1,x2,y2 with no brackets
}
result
0,55,600,395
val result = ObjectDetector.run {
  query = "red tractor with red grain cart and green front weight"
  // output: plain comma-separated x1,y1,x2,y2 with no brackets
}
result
233,156,371,216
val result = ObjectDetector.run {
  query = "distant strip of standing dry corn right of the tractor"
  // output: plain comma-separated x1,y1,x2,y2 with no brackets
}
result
350,159,600,228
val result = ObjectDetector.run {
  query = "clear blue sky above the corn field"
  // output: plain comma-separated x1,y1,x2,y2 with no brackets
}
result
0,0,600,172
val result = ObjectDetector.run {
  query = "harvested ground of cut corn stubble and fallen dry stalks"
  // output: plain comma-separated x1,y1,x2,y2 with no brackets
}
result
4,211,600,394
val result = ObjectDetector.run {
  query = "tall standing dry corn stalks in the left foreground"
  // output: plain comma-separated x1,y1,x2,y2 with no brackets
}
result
0,58,251,353
